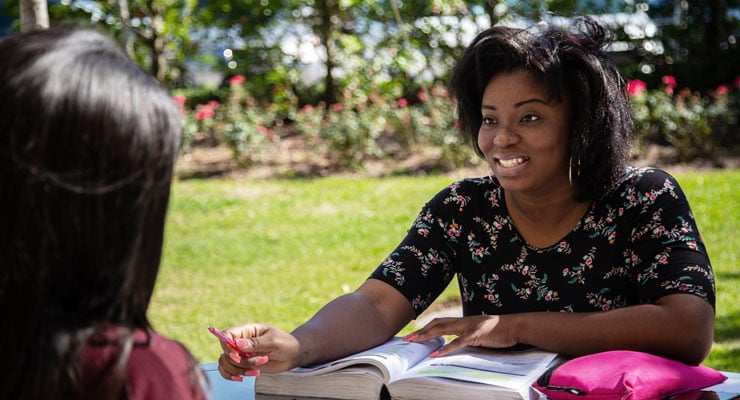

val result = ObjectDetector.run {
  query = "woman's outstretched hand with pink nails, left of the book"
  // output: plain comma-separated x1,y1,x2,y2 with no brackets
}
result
218,324,301,381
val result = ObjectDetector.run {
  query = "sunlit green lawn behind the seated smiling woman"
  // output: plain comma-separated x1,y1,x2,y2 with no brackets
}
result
150,170,740,371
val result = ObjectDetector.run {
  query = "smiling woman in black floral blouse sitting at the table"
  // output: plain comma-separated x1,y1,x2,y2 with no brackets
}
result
210,17,715,380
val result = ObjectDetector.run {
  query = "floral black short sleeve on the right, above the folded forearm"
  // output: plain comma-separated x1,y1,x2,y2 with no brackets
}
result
628,170,715,307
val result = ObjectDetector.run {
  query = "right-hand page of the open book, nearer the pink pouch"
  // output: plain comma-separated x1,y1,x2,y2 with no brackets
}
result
395,347,557,389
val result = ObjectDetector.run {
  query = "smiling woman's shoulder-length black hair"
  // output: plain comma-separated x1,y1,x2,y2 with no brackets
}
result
450,16,634,200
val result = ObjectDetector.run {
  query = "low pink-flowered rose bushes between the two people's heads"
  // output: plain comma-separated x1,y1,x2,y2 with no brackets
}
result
178,75,477,169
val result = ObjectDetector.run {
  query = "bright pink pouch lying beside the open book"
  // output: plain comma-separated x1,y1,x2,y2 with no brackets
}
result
532,350,727,400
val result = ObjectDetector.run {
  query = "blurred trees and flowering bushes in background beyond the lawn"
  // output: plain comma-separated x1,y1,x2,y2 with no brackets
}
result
0,0,740,173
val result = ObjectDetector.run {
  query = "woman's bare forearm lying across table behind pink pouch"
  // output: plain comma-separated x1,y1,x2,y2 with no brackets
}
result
502,294,714,364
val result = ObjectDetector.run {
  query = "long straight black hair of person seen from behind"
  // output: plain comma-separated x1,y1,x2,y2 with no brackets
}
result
0,28,188,399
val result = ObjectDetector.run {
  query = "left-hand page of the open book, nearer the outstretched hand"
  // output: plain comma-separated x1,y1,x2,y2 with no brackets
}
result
287,337,444,382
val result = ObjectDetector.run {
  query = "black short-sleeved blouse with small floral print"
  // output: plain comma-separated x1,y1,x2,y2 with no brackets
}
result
371,168,715,315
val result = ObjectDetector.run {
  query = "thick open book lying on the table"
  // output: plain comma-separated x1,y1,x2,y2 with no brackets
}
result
254,338,557,400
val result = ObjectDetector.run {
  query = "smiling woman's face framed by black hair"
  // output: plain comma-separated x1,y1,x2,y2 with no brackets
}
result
478,69,572,195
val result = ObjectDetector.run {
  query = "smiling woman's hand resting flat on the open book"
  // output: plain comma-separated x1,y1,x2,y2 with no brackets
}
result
404,315,517,357
